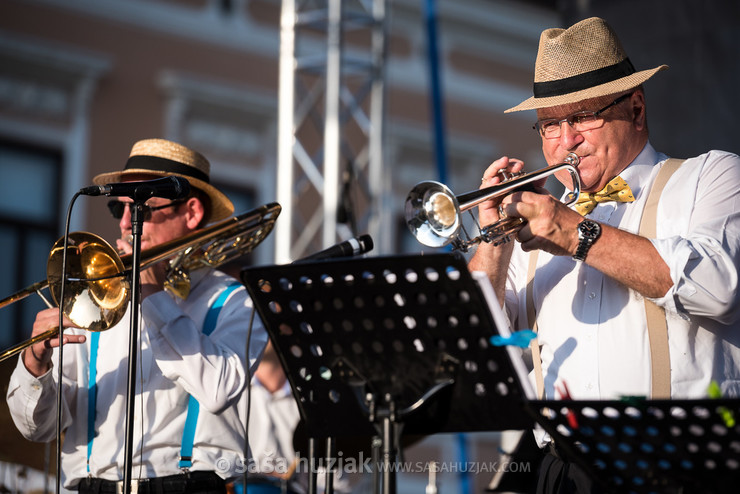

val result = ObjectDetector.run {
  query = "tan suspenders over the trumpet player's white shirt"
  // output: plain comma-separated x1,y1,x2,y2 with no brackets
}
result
526,158,684,399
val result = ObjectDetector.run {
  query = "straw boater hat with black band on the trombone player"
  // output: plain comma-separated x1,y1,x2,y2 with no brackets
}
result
93,139,234,223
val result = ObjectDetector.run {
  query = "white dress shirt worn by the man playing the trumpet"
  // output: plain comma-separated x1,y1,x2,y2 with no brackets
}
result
505,144,740,399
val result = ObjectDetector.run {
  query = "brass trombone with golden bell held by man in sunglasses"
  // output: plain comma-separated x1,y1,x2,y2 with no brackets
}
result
0,203,281,362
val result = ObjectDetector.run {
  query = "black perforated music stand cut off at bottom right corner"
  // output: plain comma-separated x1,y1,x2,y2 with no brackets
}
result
527,399,740,494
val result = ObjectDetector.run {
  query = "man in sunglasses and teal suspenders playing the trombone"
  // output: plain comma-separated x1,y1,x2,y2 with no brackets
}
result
7,139,267,493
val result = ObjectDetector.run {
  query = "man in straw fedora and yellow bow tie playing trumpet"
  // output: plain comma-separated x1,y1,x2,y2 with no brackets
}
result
469,18,740,492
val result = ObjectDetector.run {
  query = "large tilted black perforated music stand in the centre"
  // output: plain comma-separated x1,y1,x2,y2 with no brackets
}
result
242,254,534,492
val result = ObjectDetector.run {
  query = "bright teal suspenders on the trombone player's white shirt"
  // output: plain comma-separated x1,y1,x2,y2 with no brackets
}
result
87,283,240,473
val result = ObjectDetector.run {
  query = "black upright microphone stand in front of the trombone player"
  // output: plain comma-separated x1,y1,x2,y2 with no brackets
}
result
123,198,148,494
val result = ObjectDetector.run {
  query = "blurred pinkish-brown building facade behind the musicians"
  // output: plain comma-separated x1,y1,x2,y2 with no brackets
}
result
0,0,559,490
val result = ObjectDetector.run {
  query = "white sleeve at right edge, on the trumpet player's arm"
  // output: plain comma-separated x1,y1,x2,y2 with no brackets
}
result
652,151,740,324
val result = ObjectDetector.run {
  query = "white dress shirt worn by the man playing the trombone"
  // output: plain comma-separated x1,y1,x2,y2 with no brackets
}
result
7,270,267,488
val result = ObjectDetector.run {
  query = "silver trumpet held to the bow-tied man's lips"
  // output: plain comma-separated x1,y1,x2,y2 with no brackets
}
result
405,153,581,252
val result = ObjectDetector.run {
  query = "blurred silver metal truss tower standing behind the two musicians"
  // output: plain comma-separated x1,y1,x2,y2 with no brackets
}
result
275,0,390,263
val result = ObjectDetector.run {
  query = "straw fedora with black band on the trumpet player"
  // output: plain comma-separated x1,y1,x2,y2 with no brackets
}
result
504,17,668,113
